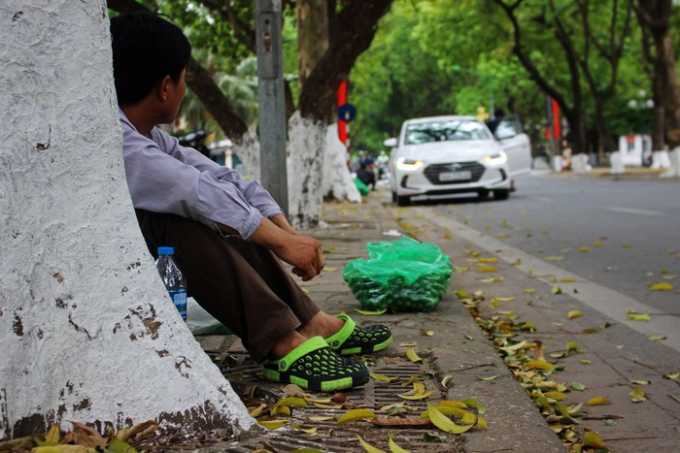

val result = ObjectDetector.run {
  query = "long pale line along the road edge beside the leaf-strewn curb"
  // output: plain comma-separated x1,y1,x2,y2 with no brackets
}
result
412,208,680,352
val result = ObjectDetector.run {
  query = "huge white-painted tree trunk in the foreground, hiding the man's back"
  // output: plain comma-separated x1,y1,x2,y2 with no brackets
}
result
0,0,257,439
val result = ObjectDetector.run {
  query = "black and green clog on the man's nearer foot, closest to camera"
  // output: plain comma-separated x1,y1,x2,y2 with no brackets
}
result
264,336,369,392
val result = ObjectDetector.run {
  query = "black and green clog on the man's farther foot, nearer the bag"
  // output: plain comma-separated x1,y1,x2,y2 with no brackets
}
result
326,315,392,355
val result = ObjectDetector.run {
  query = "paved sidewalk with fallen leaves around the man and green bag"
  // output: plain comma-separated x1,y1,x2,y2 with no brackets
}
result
198,190,566,453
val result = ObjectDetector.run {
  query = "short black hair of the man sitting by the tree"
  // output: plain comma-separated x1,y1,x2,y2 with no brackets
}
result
111,12,191,105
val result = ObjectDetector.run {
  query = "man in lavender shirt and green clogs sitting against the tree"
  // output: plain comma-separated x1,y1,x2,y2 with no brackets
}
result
111,13,392,391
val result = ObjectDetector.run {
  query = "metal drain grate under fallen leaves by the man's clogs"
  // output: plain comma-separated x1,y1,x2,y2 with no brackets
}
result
215,356,466,453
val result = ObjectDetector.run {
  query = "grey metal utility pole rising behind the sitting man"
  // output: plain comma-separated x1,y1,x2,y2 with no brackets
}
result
255,0,288,216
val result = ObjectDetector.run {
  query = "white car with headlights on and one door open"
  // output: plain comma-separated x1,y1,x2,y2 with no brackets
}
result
385,116,531,206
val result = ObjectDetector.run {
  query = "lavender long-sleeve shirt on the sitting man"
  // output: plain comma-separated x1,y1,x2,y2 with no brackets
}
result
118,109,283,239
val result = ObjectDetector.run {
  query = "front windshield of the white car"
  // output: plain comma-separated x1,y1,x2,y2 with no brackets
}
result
404,119,491,145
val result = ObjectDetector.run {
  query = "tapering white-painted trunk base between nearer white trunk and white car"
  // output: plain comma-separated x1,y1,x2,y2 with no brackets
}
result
322,123,361,203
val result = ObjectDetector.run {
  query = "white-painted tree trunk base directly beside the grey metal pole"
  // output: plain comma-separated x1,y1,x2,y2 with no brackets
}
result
288,111,327,229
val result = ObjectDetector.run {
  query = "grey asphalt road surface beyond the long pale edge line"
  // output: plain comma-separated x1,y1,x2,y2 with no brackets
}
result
416,170,680,351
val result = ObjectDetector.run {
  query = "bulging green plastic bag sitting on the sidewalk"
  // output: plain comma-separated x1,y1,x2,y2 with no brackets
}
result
343,236,453,312
